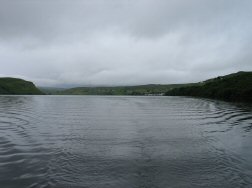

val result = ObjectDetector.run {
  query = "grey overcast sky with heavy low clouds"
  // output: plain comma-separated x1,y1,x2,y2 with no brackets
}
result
0,0,252,86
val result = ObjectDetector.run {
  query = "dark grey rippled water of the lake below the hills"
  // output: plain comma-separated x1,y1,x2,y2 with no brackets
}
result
0,96,252,188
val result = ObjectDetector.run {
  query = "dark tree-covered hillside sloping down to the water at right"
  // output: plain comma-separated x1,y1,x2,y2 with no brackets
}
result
165,72,252,102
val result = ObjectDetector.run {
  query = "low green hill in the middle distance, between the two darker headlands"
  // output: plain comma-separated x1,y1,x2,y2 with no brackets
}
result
54,84,196,95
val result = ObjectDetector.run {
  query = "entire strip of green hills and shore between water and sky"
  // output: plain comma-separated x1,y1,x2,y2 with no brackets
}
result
0,72,252,102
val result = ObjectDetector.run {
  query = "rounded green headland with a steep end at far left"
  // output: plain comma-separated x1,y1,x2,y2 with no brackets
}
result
0,78,43,95
